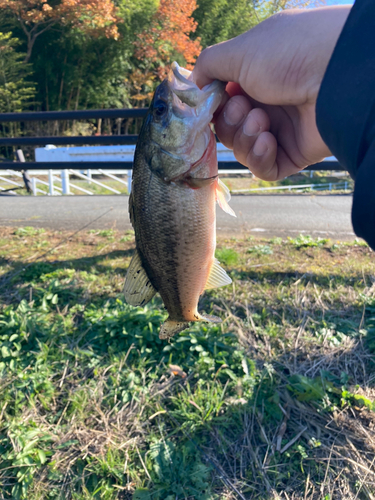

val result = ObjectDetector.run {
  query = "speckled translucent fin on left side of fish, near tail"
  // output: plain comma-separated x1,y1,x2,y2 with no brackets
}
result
124,250,156,306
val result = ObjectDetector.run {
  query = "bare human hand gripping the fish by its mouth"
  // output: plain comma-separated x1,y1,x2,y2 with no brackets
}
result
193,5,351,180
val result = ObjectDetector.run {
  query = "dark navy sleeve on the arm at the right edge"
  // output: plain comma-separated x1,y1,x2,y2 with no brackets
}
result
316,0,375,250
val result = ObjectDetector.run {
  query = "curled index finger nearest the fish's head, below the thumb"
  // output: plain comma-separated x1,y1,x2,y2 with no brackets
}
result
215,96,251,149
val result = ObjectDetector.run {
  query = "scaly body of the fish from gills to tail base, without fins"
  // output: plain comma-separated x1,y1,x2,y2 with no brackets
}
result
133,168,216,321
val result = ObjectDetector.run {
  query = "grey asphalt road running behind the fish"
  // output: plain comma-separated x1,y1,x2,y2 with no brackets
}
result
0,194,354,240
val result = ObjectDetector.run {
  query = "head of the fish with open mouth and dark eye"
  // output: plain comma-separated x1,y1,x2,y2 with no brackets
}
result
146,63,225,182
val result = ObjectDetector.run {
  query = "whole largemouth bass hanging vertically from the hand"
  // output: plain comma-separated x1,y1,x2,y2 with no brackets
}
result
124,62,235,339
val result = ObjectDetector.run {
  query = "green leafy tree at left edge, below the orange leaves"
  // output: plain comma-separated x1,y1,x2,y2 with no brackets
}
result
0,32,35,113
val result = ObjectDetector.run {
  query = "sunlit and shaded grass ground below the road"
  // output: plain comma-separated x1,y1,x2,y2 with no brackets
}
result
0,228,375,500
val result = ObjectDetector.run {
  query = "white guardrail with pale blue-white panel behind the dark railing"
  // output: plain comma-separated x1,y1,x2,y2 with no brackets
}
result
0,143,347,196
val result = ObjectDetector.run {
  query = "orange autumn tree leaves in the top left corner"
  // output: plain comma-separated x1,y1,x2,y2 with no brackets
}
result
0,0,118,62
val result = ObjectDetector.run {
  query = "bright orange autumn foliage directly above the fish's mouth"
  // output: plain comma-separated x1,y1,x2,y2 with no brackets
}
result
135,0,202,79
